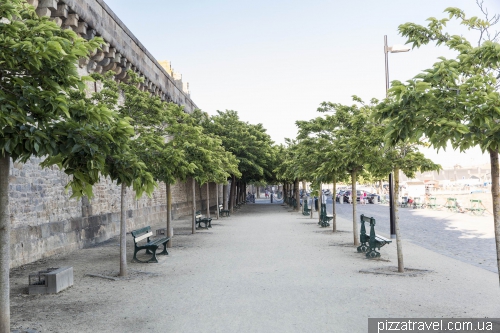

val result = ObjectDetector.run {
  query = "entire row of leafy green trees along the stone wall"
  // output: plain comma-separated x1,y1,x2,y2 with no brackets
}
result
0,0,275,332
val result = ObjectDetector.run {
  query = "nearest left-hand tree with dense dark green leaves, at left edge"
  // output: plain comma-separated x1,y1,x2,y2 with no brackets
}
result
0,0,127,332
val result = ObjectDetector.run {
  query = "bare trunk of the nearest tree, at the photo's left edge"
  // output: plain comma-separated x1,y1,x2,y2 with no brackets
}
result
0,153,10,333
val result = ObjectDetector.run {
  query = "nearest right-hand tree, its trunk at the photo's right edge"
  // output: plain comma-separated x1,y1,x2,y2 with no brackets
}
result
380,8,500,279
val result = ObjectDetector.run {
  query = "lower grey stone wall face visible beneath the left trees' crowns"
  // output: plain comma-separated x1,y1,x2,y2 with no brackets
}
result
9,159,222,267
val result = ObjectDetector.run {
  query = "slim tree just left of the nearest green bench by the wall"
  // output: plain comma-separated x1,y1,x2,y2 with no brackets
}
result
99,71,157,276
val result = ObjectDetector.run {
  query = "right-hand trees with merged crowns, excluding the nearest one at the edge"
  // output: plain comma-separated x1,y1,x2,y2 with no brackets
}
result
277,96,440,272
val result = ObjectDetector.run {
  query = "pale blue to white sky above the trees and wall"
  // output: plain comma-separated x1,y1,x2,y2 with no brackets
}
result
105,0,500,163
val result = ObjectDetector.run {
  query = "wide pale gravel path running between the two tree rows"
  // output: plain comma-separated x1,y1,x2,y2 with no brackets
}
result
11,200,500,333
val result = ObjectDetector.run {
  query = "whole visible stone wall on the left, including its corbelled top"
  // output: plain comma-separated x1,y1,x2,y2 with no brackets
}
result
5,0,222,267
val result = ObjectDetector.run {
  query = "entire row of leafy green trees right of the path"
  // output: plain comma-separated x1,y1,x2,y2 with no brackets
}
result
277,2,500,286
